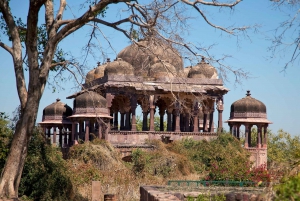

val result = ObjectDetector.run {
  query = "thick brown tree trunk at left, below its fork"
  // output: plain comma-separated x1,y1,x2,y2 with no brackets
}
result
0,97,39,199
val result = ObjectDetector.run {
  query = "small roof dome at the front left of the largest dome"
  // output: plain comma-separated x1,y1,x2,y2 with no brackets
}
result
104,58,134,75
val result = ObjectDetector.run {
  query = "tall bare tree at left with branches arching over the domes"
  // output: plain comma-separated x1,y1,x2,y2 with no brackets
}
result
0,0,249,198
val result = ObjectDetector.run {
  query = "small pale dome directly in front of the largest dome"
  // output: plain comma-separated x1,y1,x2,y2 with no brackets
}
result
149,61,177,78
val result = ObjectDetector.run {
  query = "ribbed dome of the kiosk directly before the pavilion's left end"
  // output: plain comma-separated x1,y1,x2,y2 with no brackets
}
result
74,91,106,109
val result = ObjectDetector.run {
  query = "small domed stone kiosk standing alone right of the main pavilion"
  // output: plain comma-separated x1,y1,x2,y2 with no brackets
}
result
226,91,272,167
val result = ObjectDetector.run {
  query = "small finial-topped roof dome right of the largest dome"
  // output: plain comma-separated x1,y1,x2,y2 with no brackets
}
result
188,57,218,79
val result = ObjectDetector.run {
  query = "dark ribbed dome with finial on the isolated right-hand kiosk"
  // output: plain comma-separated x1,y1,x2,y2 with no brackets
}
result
230,91,267,117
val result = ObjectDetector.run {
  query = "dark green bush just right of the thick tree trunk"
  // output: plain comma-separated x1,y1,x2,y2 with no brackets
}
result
19,129,74,200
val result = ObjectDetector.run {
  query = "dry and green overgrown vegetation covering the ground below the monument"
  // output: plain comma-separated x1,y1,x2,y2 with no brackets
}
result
0,113,300,200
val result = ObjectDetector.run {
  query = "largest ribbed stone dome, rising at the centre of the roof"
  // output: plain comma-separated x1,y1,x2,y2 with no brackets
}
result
118,37,183,75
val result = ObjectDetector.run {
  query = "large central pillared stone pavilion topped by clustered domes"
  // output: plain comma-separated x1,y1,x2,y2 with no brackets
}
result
67,37,228,148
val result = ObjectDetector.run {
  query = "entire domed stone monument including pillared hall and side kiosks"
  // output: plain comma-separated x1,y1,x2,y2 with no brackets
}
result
40,37,271,167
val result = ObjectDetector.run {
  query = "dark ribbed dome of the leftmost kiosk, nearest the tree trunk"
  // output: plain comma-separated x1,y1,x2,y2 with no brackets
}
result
43,99,73,120
